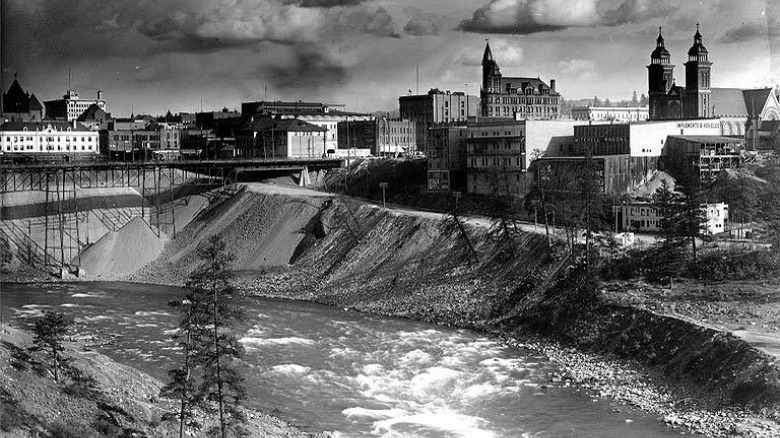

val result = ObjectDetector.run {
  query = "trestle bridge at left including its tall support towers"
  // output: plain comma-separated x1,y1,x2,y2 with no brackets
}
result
0,158,344,275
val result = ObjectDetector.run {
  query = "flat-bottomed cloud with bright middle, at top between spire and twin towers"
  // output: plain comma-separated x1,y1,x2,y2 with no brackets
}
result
458,0,677,35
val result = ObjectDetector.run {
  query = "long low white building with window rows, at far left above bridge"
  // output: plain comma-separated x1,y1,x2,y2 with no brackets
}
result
0,121,100,155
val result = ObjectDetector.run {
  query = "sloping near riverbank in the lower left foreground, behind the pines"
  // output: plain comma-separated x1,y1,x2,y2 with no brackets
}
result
0,326,335,438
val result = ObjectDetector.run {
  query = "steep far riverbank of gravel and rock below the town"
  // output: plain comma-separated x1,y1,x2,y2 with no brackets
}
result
4,181,780,436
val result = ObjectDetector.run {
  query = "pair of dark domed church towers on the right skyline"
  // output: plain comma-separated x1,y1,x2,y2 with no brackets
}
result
647,23,715,120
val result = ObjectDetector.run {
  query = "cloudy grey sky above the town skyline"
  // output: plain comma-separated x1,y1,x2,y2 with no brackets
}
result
0,0,780,116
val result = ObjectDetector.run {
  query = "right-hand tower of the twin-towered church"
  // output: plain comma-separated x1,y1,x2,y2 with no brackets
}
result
683,23,712,119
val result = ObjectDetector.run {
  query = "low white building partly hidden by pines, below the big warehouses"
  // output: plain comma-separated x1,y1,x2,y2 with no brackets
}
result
621,202,729,235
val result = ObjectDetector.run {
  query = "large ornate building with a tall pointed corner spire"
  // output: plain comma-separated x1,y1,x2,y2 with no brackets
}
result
480,43,561,119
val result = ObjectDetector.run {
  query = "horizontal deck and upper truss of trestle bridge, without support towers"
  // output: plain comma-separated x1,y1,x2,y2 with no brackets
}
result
0,158,344,193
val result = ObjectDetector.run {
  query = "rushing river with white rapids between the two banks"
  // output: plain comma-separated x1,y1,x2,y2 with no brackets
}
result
2,283,696,438
